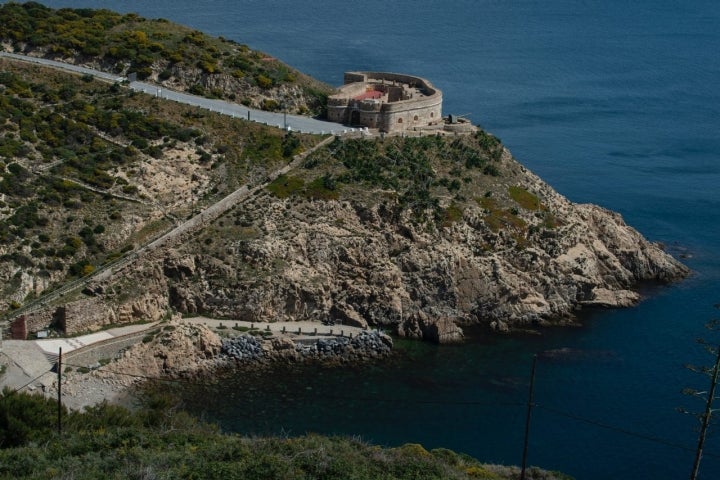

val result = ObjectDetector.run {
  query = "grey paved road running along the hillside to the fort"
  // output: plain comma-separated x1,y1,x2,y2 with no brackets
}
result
0,52,348,135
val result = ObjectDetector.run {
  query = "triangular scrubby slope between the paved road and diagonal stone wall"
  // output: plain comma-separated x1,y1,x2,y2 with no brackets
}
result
0,59,318,308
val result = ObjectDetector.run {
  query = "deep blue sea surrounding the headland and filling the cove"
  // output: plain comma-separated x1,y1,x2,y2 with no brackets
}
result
7,0,720,479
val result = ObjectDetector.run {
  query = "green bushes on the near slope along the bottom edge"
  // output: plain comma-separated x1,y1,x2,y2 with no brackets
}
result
0,390,567,480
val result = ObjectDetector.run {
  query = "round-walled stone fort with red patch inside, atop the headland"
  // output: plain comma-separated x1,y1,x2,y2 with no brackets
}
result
328,72,444,133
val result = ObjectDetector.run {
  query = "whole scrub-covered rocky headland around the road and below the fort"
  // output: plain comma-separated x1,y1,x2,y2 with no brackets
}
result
0,5,688,371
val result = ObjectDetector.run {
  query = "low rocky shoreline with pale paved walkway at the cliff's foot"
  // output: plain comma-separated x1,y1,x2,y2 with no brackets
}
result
0,317,393,410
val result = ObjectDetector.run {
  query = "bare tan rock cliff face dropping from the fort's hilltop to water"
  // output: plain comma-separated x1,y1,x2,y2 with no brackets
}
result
77,142,688,343
